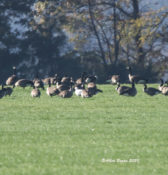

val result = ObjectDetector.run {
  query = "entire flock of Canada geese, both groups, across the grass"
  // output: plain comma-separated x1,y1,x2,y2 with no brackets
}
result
0,67,168,98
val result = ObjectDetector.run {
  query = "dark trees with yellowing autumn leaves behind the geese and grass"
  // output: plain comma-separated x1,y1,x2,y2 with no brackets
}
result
0,0,168,81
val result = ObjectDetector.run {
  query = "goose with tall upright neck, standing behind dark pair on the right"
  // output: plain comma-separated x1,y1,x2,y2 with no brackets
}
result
127,67,147,84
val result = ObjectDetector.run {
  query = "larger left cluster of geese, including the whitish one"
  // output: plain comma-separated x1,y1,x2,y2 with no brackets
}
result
0,67,103,98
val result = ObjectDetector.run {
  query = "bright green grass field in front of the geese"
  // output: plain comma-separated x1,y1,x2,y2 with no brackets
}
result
0,85,168,175
